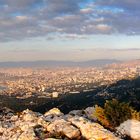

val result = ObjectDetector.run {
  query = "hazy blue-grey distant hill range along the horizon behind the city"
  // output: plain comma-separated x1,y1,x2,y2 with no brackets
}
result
0,59,121,67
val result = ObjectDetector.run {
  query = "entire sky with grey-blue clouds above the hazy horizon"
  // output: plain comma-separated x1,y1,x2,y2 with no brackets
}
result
0,0,140,61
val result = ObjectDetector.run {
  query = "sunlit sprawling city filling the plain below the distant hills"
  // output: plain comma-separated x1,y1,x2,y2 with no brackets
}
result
0,61,140,98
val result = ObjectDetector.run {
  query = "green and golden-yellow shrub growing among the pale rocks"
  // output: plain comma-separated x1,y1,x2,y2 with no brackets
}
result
93,99,140,129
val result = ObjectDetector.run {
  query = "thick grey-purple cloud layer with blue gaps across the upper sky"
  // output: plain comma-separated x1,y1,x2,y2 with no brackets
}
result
0,0,140,42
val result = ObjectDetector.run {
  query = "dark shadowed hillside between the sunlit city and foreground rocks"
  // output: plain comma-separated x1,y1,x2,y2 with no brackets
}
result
0,77,140,113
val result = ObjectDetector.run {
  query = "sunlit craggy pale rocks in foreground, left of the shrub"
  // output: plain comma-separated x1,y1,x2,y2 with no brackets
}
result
0,108,120,140
